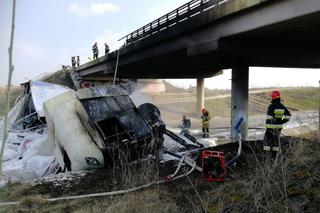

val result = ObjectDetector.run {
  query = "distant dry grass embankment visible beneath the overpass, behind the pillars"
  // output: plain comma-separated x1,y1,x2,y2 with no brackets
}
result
154,87,320,120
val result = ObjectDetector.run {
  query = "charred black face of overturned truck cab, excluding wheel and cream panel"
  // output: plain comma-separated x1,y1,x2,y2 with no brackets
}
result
80,95,164,165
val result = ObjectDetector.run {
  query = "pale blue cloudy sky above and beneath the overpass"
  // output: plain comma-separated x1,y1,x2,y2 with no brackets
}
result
0,0,320,89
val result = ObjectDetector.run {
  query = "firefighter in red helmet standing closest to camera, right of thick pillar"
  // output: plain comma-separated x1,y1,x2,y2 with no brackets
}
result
263,90,291,157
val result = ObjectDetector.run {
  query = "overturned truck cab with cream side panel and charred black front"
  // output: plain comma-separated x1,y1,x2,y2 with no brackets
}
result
48,83,165,170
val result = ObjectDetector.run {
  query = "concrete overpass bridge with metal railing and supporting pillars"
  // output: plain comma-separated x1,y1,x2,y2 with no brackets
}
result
76,0,320,141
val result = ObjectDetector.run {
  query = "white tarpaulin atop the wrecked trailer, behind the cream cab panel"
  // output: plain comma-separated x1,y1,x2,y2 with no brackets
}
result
30,81,71,117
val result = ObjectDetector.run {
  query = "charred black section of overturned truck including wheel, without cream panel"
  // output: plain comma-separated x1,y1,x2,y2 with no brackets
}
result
78,87,165,166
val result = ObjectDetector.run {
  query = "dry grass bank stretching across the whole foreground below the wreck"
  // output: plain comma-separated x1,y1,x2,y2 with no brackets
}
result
0,133,320,212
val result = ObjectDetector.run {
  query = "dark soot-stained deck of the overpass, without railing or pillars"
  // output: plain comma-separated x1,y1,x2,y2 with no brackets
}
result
78,0,320,78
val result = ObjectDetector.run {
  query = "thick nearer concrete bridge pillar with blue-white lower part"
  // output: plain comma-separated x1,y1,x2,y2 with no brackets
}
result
231,65,249,142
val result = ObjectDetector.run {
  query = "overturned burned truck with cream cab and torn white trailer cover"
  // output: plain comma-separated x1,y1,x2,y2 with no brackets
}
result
10,81,165,171
